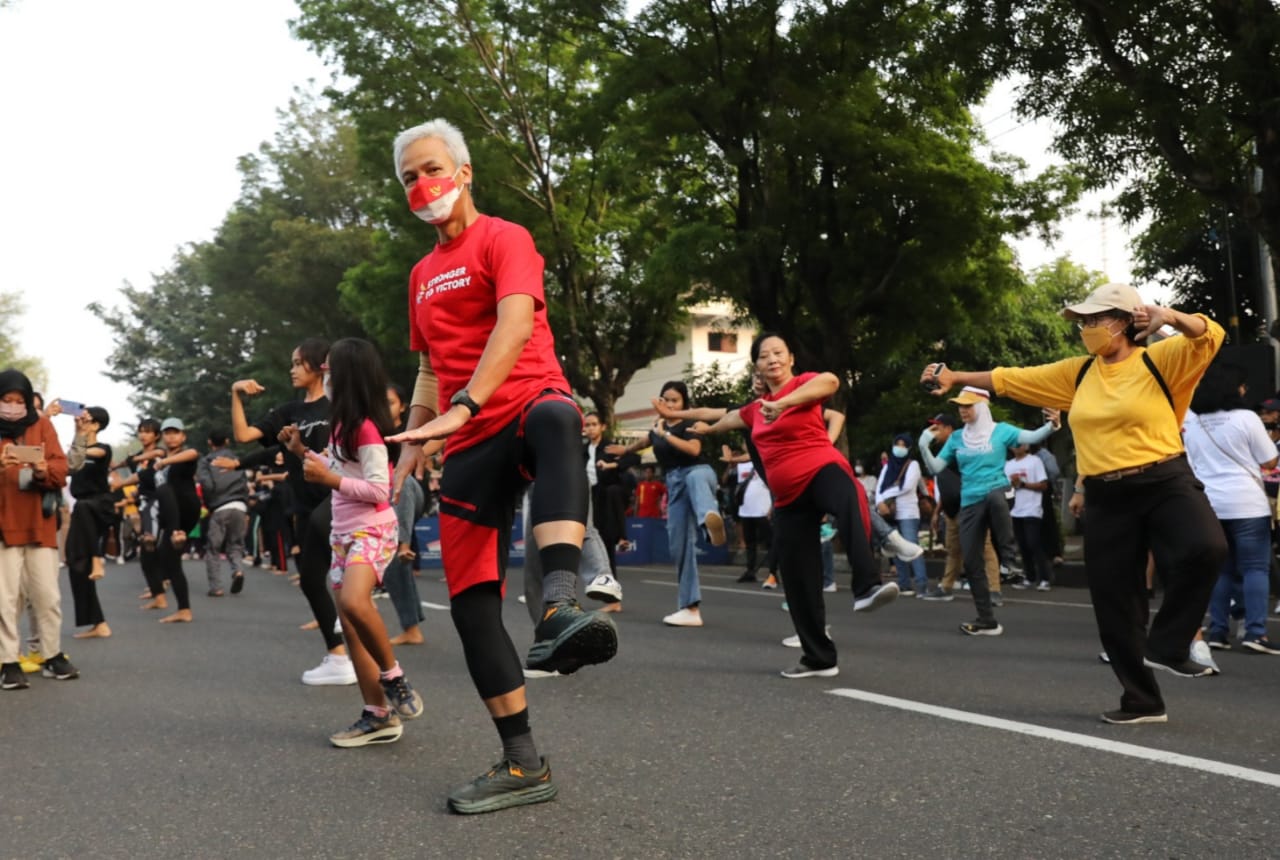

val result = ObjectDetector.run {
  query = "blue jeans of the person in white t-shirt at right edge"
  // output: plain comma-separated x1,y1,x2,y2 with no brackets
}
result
1208,517,1271,637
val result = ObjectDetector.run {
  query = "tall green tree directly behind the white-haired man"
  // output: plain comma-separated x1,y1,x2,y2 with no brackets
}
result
296,0,698,422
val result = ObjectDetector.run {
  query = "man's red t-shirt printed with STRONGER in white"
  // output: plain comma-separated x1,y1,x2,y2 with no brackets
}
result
408,215,570,457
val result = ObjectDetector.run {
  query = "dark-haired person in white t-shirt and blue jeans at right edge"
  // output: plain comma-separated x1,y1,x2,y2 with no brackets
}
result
1177,362,1280,654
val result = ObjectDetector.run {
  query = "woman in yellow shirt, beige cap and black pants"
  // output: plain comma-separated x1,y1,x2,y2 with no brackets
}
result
922,284,1226,724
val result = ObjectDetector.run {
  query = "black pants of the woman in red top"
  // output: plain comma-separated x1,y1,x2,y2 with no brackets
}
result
773,463,879,669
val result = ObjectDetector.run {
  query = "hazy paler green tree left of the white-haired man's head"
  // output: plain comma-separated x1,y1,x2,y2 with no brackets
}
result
93,95,376,431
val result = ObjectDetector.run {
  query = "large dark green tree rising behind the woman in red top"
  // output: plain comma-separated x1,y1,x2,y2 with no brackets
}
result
608,0,1076,424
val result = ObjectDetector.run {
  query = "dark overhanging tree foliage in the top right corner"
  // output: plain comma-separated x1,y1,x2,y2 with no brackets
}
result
963,0,1280,299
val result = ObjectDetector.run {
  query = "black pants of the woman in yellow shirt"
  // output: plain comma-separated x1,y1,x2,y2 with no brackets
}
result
1084,457,1228,713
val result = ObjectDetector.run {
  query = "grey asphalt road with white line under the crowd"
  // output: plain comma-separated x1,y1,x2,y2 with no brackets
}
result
0,563,1280,860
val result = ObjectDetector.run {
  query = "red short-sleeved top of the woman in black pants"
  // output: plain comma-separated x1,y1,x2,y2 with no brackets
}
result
737,374,854,507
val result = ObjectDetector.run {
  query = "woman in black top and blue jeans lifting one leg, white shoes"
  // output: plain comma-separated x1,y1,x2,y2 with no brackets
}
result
605,380,724,627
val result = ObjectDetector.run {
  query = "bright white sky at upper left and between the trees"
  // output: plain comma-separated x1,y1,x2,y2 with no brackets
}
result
0,0,1130,440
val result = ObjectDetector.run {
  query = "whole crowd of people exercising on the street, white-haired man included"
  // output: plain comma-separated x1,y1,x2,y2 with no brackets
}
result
0,120,1280,814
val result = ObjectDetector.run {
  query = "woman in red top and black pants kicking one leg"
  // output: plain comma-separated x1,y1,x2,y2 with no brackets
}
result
700,331,897,678
